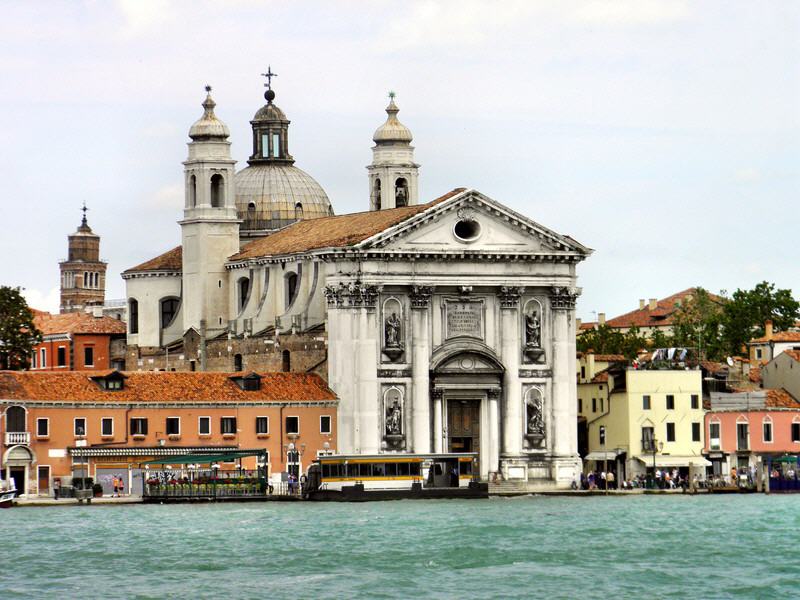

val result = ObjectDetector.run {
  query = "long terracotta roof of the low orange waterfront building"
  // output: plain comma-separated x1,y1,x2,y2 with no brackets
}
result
0,371,336,403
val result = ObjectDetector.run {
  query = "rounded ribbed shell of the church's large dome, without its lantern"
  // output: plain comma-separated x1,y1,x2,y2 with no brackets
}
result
236,163,333,234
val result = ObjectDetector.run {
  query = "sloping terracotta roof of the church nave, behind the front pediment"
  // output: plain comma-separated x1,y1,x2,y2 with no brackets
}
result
229,188,465,261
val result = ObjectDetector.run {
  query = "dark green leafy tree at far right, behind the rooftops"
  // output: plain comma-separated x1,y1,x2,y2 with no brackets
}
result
722,281,800,354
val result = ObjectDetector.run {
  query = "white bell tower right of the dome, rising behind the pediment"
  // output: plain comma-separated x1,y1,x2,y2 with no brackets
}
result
367,92,419,210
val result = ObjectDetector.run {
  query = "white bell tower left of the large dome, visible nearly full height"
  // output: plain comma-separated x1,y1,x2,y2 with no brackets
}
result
180,86,240,334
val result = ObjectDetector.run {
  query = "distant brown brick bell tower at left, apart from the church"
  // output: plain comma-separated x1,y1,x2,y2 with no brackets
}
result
58,205,107,313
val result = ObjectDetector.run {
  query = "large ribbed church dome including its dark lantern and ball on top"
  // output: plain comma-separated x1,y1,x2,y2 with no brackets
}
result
236,69,333,238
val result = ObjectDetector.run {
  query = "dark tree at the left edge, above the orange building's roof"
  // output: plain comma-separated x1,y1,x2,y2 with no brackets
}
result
0,286,42,370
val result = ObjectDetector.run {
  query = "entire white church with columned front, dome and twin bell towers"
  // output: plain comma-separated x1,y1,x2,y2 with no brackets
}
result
123,77,591,489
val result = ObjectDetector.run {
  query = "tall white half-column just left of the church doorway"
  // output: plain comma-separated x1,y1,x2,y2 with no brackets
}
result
411,286,432,454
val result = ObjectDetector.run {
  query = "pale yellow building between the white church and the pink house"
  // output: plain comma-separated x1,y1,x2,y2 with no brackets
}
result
578,360,709,480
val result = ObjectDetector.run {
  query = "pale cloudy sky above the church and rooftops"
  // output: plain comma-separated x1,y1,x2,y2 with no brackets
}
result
0,0,800,320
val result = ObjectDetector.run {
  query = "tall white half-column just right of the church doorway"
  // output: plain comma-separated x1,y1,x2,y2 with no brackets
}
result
498,287,524,456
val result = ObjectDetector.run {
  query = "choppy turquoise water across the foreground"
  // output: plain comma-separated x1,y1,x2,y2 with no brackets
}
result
0,494,800,599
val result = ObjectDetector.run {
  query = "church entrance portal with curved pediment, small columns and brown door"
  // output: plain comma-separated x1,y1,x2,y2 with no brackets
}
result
431,339,505,478
